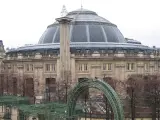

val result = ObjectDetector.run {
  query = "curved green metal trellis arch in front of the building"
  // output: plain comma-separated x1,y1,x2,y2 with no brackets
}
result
67,79,124,120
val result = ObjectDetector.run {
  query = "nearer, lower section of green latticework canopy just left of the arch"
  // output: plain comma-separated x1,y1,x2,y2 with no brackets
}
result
18,102,83,120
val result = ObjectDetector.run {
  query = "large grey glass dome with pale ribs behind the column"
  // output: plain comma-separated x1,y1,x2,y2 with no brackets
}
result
38,9,126,44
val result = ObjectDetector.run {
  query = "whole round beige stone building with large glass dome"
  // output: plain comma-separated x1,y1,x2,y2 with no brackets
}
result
1,9,160,99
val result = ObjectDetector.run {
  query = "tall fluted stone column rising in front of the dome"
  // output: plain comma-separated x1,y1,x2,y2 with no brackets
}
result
56,17,72,81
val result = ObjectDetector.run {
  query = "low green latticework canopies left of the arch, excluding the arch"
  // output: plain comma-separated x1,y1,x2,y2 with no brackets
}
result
0,95,83,120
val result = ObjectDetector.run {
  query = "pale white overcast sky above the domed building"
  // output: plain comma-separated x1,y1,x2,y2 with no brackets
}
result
0,0,160,47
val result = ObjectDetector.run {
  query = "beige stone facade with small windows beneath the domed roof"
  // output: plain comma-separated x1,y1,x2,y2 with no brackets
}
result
3,48,160,96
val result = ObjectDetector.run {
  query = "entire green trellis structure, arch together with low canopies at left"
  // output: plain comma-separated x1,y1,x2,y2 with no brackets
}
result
0,79,124,120
